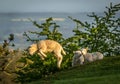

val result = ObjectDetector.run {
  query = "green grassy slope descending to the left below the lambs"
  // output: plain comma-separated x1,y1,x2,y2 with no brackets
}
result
29,56,120,84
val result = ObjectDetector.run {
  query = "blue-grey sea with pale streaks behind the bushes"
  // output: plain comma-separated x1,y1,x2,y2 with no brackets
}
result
0,12,119,49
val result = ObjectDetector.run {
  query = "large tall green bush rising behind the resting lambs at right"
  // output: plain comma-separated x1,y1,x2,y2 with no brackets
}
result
69,3,120,56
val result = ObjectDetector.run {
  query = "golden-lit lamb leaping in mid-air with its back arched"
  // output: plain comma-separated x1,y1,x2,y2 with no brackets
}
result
28,40,66,68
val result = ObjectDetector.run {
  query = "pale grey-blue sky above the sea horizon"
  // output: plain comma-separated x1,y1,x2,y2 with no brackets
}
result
0,0,120,13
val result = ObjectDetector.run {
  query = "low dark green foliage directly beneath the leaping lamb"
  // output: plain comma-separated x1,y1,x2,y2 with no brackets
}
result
16,54,58,83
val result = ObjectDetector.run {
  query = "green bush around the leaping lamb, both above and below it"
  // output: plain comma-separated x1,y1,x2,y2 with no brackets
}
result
16,17,78,83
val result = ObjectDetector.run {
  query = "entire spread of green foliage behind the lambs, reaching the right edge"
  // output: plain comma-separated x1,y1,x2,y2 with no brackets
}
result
16,3,120,83
